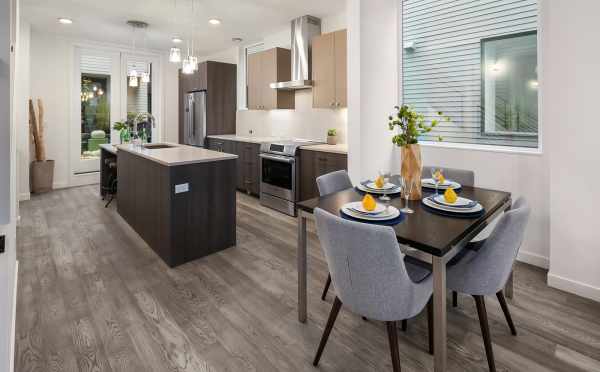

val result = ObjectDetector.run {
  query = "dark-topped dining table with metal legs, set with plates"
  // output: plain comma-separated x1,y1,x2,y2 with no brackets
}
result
297,186,512,372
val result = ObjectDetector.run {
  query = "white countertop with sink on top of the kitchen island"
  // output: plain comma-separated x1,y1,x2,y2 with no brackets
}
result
116,143,238,167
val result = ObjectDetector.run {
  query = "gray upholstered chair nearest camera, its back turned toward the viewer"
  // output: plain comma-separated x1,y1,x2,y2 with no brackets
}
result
313,208,433,371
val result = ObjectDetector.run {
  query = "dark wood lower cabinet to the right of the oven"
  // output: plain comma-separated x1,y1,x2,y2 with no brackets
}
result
300,149,348,200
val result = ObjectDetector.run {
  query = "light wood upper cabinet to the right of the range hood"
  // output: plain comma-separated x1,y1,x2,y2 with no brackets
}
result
312,30,348,108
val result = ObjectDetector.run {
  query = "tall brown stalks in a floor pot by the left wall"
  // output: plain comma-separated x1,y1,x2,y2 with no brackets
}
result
29,99,54,194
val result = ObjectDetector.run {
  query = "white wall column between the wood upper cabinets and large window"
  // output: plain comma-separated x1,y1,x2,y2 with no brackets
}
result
347,0,400,182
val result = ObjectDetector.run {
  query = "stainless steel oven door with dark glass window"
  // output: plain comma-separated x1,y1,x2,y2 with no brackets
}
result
260,154,296,202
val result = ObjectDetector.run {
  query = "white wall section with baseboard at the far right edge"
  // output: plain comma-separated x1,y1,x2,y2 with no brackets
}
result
542,0,600,301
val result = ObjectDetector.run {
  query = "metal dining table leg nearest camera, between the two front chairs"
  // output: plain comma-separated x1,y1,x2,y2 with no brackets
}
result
432,256,448,372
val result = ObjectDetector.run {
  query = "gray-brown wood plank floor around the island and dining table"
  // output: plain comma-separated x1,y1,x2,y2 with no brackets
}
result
15,186,600,372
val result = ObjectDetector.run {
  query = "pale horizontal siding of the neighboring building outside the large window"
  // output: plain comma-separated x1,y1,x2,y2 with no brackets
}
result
402,0,538,147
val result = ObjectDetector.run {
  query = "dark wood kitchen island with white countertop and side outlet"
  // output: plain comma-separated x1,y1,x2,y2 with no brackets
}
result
116,144,237,267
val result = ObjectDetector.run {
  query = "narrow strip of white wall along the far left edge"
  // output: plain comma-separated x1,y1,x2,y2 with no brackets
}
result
0,0,18,371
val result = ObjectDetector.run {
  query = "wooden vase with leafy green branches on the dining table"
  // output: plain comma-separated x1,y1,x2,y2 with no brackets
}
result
388,105,450,200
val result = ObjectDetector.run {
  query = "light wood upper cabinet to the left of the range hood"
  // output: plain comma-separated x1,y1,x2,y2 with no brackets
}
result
247,48,295,110
